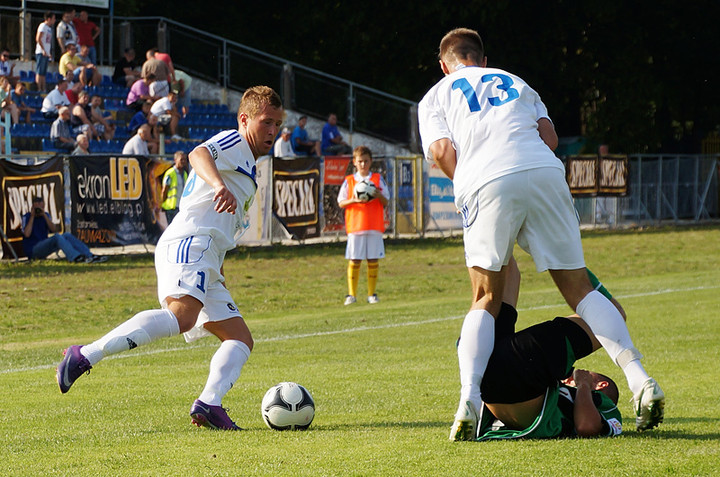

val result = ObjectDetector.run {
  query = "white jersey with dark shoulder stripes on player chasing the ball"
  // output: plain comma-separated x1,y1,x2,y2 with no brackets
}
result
160,130,257,251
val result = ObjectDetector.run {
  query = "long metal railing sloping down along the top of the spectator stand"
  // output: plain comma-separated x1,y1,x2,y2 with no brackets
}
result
0,7,419,151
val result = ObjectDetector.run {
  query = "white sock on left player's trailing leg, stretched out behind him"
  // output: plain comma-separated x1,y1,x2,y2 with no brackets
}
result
80,310,180,366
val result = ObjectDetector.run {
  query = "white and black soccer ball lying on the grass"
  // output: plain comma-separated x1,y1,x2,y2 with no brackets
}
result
260,383,315,431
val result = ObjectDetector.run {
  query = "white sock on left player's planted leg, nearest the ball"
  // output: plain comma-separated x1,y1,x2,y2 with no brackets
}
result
198,340,250,406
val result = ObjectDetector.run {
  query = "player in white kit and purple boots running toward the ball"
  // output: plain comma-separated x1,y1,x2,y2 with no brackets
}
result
56,86,283,430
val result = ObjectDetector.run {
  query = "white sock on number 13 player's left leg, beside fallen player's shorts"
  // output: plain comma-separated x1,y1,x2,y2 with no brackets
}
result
458,310,495,409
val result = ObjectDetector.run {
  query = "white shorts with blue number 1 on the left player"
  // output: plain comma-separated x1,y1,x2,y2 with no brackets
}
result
155,235,242,342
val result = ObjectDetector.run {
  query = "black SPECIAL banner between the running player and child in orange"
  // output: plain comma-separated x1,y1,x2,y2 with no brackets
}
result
273,157,320,239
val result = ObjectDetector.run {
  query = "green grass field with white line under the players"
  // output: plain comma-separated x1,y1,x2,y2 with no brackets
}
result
0,227,720,476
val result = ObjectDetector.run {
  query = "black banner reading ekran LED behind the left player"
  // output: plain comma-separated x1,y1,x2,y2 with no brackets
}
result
68,156,167,246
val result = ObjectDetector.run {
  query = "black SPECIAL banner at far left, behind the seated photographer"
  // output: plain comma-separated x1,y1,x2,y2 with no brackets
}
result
0,157,65,258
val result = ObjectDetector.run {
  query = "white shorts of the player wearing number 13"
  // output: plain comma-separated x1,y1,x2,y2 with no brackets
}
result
461,167,585,272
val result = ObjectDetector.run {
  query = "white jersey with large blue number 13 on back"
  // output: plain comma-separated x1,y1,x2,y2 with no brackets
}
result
418,66,563,208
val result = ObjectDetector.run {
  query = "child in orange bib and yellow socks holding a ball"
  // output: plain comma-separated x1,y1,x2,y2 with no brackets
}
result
338,146,390,305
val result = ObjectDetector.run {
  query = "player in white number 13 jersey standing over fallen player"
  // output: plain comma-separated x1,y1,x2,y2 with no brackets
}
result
418,28,665,440
